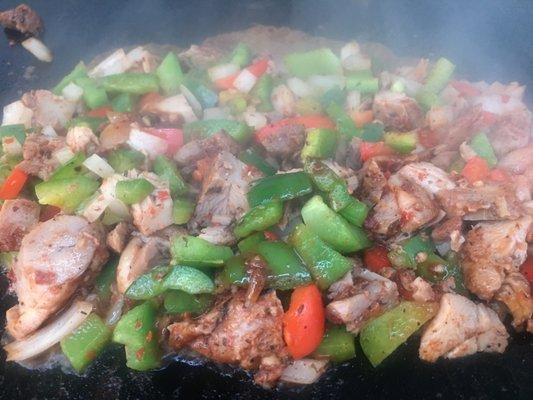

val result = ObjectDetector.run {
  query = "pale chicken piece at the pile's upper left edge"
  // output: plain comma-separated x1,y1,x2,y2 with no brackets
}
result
21,90,76,130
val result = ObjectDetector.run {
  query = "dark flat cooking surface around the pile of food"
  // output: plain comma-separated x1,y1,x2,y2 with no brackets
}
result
0,0,533,400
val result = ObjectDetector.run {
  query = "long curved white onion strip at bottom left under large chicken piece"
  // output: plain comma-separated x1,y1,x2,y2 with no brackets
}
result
4,300,93,361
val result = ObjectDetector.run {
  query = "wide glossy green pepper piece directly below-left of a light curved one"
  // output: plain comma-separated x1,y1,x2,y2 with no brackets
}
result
289,224,353,289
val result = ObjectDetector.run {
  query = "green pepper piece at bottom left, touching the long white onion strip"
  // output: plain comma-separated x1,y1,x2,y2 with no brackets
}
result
60,313,111,372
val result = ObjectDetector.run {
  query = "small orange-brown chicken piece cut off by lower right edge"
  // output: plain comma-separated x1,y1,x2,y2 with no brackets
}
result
494,272,533,328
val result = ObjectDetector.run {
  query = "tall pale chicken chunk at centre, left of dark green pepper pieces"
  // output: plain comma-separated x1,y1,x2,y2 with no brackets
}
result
189,151,257,244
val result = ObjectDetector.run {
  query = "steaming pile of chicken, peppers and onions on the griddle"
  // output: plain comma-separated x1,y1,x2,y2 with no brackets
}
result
0,25,533,387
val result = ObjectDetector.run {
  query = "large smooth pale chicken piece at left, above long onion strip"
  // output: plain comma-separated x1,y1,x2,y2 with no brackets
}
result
6,215,108,339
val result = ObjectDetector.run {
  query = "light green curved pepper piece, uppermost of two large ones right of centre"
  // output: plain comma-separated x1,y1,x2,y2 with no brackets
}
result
302,196,372,253
